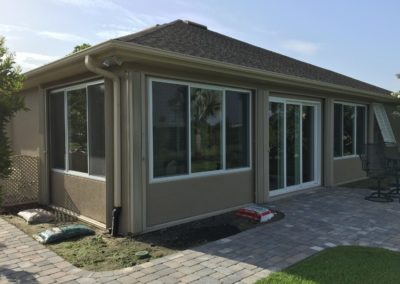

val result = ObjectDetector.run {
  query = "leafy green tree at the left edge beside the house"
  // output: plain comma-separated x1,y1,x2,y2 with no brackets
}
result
0,36,25,178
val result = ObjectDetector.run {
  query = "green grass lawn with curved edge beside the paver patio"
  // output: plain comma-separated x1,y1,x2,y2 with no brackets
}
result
256,246,400,284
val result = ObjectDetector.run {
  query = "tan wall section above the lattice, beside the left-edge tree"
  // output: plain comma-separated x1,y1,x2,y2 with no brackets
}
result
9,89,42,157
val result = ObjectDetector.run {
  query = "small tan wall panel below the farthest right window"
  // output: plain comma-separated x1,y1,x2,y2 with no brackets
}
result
333,157,366,185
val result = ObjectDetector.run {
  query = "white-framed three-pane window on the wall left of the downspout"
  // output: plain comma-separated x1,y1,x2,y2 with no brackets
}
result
49,82,105,176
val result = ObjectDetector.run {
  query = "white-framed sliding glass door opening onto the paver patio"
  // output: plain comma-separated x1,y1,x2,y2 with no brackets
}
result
269,98,320,195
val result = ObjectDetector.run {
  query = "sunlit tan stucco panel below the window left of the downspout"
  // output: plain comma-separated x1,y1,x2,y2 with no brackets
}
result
50,172,106,223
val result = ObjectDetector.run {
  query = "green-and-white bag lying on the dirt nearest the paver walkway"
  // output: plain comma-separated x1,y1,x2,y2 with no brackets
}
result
33,224,94,244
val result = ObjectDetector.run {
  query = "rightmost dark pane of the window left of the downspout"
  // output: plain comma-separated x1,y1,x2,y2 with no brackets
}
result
88,84,106,176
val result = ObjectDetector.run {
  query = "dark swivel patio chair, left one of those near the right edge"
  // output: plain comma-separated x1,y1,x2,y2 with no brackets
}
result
359,144,393,202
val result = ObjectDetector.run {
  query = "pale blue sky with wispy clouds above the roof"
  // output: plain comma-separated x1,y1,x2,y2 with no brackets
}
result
0,0,400,91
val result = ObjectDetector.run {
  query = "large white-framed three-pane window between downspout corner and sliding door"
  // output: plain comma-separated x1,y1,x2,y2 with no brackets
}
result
149,79,250,179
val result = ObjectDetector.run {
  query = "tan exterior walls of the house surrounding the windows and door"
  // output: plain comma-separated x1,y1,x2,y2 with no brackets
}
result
10,58,400,233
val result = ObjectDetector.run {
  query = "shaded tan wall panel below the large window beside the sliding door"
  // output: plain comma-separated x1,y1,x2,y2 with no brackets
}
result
147,171,254,226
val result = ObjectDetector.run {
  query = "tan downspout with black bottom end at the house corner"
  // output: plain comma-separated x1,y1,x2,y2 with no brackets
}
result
85,55,122,237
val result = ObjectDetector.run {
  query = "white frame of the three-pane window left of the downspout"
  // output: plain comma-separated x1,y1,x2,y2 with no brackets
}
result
49,80,106,181
